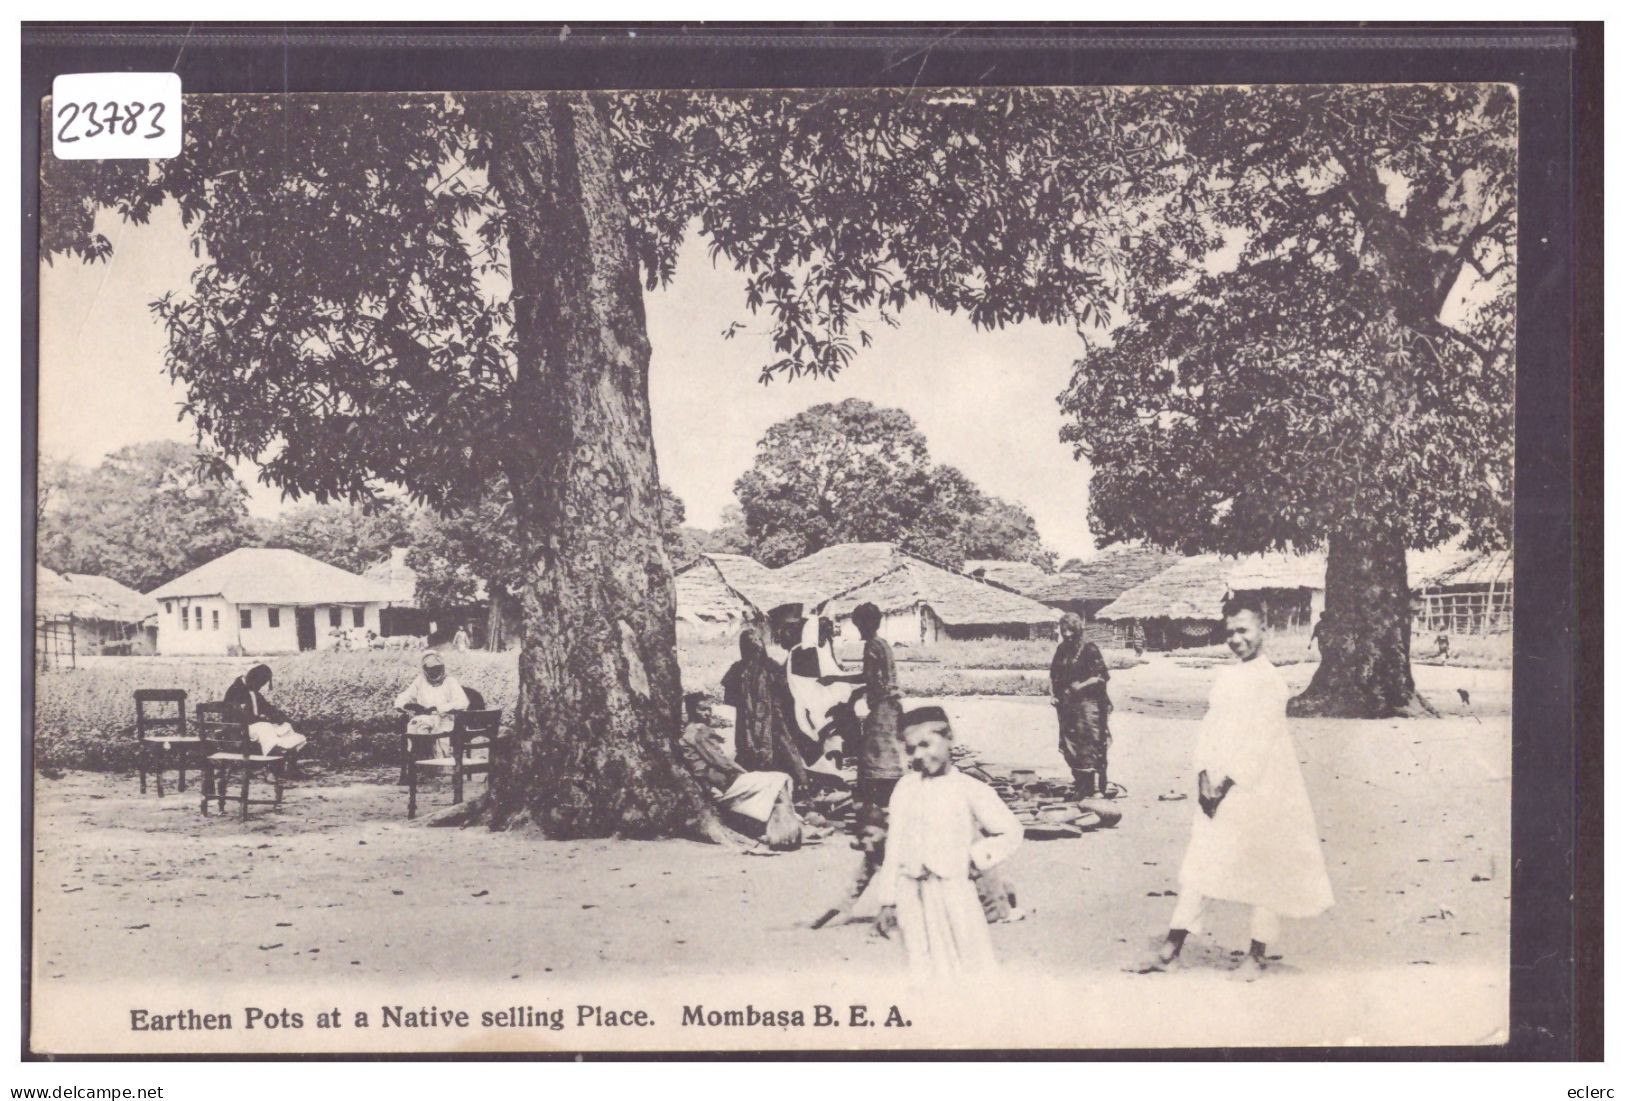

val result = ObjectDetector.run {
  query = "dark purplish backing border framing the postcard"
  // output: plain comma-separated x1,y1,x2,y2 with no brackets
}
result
21,23,1602,1060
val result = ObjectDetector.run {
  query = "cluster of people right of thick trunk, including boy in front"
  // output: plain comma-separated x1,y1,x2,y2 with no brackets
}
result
679,602,1022,978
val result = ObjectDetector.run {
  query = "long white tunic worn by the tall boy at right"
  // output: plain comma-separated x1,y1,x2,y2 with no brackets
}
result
1180,654,1333,918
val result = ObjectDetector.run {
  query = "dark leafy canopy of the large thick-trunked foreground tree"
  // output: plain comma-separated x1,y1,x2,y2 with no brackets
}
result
42,89,1157,516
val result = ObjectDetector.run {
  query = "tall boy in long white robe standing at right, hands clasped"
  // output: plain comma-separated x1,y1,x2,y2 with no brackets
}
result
1147,598,1333,978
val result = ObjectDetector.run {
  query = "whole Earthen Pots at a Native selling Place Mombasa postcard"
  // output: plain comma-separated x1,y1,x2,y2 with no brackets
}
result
31,83,1519,1056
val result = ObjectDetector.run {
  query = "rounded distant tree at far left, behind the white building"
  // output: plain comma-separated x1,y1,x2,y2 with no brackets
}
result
37,440,257,593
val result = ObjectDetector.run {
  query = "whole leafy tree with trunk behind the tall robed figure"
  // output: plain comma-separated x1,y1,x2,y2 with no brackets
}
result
1063,84,1518,716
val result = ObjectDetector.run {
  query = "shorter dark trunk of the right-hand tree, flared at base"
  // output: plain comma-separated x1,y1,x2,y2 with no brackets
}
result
1287,533,1430,719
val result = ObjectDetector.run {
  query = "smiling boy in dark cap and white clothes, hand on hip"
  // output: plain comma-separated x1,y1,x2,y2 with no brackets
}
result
876,706,1022,981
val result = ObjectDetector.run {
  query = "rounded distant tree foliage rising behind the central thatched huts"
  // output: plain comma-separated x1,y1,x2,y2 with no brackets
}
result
735,398,1048,567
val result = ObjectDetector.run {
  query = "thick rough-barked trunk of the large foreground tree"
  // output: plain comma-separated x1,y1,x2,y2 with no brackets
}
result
483,93,704,838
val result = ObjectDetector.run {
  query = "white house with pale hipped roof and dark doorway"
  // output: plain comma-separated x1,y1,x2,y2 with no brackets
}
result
148,547,390,654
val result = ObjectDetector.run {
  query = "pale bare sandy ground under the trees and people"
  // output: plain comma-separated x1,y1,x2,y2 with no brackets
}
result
34,656,1511,1043
